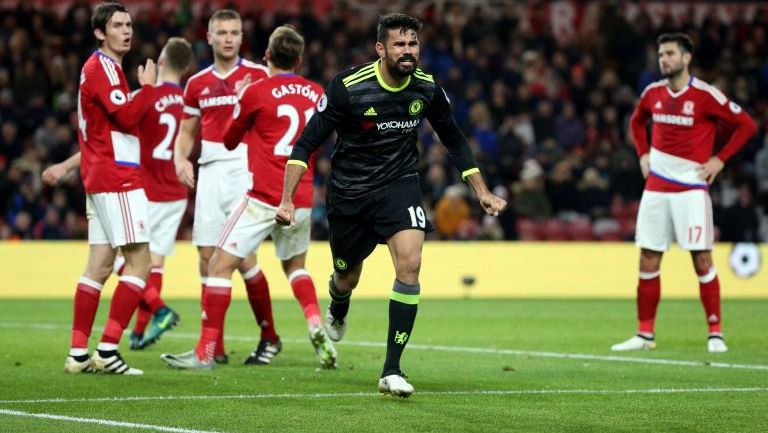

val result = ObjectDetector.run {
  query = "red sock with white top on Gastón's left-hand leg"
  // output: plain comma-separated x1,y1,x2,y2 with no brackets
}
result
195,278,232,363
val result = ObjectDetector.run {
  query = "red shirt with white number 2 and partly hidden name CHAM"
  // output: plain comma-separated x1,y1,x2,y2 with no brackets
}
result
138,83,187,202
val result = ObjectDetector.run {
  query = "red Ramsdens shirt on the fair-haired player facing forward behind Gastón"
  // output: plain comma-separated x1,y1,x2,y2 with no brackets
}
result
184,59,268,164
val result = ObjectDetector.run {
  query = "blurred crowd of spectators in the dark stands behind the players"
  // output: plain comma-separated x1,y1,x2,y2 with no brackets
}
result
0,2,768,241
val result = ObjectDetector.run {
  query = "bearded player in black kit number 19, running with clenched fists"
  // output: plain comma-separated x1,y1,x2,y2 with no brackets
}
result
275,13,507,397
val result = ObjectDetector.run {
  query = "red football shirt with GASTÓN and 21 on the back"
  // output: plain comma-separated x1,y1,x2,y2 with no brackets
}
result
224,74,323,208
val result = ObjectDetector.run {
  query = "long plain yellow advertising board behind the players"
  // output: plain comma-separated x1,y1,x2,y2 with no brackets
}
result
0,242,768,299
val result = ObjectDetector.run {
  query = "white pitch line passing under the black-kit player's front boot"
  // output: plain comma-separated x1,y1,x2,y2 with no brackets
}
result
0,387,768,404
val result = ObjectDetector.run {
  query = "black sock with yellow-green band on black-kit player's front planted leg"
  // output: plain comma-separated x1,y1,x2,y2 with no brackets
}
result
381,280,421,377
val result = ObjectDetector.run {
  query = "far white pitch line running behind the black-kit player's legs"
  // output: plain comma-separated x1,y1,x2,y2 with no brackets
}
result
0,322,768,371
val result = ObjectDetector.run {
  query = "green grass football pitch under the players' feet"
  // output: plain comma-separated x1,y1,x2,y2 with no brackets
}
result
0,299,768,433
